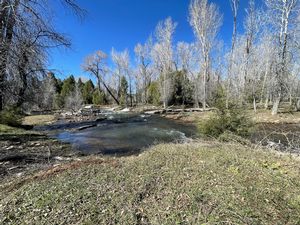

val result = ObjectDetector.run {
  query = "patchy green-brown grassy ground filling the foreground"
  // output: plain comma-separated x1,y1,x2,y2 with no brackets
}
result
0,142,300,225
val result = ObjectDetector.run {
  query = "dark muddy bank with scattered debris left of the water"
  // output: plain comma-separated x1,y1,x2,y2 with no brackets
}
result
0,132,79,183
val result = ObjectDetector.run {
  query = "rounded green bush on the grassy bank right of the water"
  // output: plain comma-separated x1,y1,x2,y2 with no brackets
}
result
198,87,254,138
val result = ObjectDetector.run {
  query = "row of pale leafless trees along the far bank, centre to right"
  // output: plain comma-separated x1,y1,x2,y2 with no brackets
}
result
83,0,300,114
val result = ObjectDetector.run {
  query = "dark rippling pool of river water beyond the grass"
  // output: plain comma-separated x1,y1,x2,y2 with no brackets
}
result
37,113,196,156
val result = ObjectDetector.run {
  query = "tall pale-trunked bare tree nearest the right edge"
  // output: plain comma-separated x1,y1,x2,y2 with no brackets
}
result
265,0,299,115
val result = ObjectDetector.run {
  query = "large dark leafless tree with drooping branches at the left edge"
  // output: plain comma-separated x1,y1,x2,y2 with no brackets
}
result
0,0,81,111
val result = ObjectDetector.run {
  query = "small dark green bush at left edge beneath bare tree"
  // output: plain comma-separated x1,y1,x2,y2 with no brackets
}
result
0,107,22,127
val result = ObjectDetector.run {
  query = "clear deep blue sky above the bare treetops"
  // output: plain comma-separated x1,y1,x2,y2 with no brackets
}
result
49,0,262,81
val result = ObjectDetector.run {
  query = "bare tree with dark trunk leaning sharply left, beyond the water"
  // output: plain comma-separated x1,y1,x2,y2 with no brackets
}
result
82,50,120,105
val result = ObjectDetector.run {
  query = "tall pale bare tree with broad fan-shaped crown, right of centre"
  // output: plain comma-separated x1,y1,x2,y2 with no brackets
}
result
189,0,222,109
